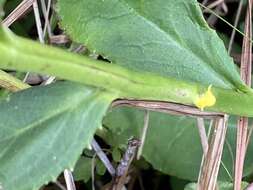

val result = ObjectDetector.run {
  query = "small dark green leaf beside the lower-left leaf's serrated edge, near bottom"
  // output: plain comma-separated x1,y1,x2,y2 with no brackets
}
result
73,156,92,183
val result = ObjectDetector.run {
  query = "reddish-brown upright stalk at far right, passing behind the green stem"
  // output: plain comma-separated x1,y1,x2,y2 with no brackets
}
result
234,0,253,190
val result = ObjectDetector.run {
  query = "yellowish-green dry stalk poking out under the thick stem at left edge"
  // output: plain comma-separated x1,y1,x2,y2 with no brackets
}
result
0,70,29,92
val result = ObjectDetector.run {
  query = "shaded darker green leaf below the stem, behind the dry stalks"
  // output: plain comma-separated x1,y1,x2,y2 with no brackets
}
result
99,108,253,181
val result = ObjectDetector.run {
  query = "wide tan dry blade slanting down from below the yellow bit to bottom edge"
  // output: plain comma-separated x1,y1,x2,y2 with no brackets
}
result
198,115,227,190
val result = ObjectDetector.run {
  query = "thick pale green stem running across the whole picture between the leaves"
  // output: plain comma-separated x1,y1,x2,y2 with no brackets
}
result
0,27,253,117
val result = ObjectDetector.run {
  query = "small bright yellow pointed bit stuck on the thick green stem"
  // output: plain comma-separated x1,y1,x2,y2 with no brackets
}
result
195,85,216,111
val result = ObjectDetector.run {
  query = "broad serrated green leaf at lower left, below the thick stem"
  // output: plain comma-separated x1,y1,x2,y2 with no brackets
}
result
0,82,114,190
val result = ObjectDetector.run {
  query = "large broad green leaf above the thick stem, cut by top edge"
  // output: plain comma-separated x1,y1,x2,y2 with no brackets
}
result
58,0,245,91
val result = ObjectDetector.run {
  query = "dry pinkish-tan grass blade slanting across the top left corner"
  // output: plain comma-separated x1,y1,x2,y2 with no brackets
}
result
2,0,34,27
